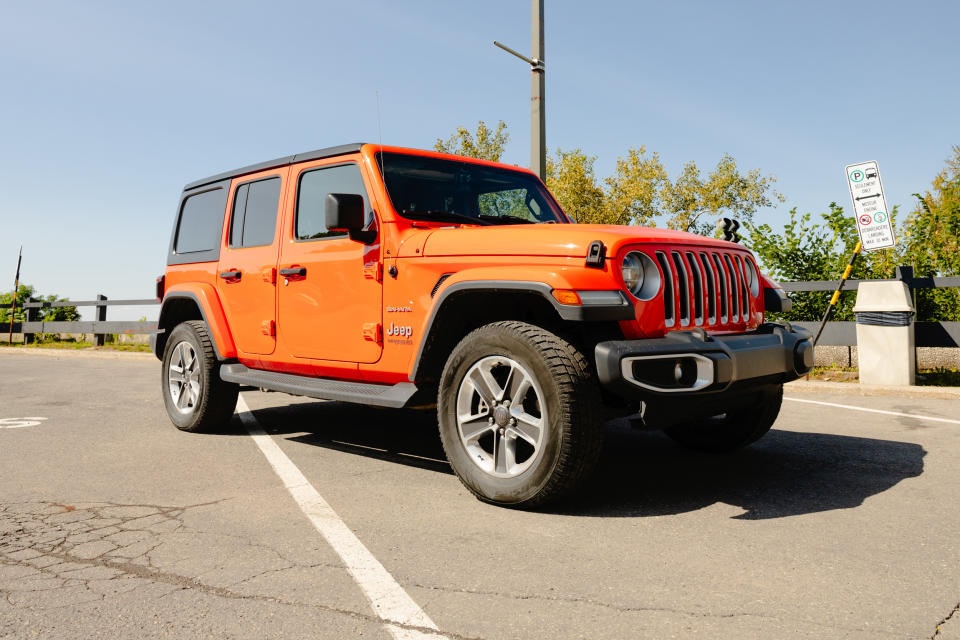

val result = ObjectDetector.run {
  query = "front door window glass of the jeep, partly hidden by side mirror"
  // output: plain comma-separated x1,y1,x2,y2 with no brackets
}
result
294,163,373,240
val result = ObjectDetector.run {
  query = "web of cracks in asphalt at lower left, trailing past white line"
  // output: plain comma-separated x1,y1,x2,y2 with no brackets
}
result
0,501,472,640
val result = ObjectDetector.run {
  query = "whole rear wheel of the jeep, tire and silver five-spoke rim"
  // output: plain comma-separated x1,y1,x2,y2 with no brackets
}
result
162,320,240,431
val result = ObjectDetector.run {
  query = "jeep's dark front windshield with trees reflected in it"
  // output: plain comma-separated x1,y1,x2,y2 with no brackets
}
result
377,153,567,225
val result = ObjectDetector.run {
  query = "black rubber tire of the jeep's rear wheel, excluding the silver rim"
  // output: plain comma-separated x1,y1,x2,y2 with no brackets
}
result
161,320,240,432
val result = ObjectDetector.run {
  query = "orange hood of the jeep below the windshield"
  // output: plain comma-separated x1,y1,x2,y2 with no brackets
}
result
423,224,745,257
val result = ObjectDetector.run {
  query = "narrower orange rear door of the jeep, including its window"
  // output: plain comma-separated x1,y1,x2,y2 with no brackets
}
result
217,169,286,355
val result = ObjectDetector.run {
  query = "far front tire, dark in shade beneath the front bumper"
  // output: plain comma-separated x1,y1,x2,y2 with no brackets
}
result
664,384,783,453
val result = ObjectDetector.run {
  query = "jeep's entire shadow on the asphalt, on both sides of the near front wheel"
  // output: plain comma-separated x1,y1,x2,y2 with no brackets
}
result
225,402,926,520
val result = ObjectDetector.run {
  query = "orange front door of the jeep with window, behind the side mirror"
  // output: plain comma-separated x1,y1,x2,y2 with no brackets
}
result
277,160,382,363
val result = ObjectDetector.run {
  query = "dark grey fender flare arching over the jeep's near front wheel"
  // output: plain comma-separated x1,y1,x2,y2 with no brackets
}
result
409,277,635,380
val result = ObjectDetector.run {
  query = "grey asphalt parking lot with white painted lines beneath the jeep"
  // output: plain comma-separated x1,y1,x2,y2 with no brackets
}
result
0,350,960,639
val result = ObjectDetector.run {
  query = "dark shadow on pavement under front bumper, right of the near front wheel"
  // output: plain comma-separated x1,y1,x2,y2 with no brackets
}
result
553,421,926,520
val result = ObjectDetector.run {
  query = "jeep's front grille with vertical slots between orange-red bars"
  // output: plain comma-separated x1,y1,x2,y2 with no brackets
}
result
651,248,750,328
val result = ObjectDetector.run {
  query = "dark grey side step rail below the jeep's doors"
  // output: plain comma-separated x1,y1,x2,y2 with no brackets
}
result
220,364,417,409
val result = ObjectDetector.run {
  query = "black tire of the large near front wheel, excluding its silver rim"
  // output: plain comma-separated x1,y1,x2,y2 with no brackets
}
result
437,321,603,508
